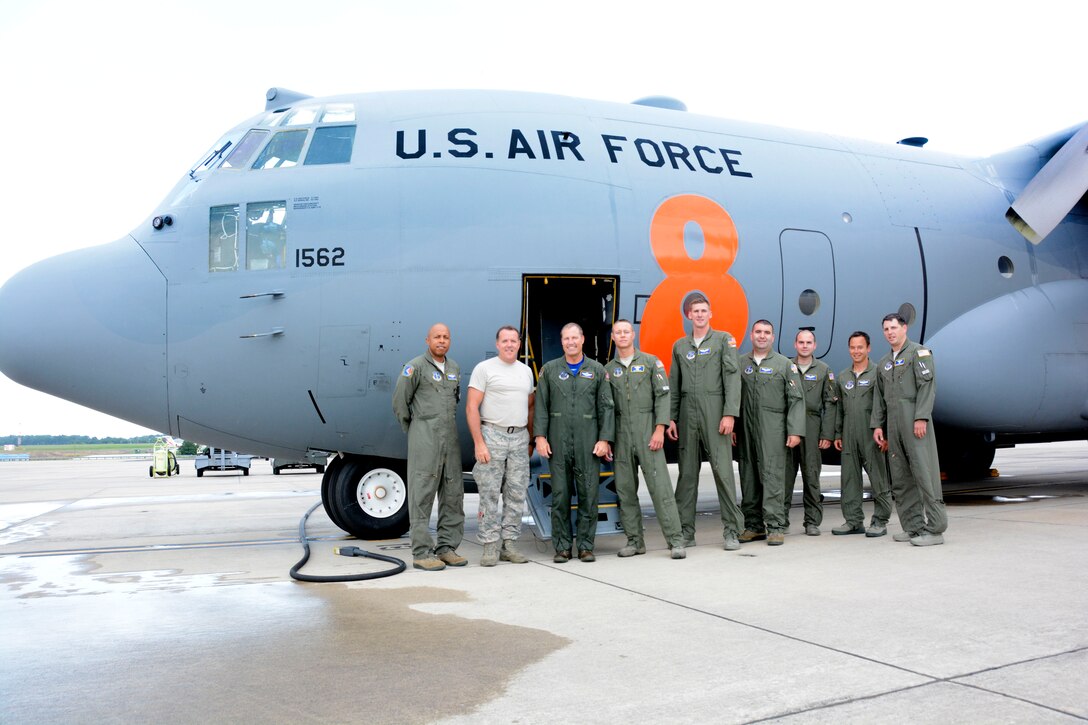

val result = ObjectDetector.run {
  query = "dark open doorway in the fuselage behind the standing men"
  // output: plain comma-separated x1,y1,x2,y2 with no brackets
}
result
521,274,619,374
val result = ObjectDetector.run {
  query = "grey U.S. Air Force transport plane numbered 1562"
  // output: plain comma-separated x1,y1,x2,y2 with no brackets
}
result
0,88,1088,538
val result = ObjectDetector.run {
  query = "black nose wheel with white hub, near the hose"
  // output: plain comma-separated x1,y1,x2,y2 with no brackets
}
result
331,455,408,540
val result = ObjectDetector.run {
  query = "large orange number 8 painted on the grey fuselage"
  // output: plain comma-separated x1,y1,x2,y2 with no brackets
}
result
640,194,747,367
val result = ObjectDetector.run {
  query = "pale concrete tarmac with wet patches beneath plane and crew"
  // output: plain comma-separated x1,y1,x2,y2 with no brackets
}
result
0,441,1088,725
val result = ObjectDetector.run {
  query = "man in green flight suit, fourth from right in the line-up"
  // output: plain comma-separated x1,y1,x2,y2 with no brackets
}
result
738,320,805,546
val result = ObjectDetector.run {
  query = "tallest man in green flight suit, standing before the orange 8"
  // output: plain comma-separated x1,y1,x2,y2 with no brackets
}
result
668,294,744,551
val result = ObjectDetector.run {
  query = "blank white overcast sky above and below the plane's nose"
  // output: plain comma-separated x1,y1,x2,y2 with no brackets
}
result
0,0,1088,437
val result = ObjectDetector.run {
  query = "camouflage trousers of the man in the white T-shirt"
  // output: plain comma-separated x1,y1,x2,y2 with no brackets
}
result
472,423,529,544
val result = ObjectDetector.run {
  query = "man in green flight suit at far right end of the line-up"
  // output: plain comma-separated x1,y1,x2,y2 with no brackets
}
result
869,312,948,546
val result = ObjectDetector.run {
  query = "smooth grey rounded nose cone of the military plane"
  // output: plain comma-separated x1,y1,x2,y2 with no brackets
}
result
0,237,170,431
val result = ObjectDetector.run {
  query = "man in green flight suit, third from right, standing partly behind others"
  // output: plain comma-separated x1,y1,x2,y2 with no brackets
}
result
783,329,839,537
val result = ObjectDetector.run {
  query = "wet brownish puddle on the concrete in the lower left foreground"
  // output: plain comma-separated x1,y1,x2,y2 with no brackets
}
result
0,556,569,723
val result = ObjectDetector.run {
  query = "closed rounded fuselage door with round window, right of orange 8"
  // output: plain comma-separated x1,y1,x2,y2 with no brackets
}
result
775,229,836,357
